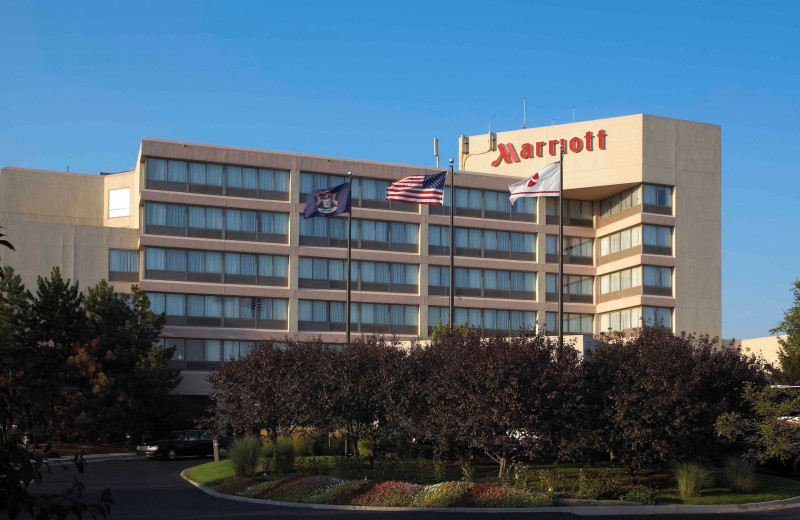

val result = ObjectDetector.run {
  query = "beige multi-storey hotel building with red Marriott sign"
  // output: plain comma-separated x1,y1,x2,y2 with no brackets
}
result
0,114,721,393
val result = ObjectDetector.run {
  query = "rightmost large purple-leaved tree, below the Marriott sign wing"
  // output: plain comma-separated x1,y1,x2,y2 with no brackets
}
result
585,327,766,475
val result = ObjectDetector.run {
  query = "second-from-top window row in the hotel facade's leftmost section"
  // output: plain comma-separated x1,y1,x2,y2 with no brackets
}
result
145,202,290,235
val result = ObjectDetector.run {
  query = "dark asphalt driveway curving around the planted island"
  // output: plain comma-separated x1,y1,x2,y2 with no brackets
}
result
28,459,800,520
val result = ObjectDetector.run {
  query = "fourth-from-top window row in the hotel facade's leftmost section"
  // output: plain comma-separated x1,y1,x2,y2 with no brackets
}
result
147,292,289,321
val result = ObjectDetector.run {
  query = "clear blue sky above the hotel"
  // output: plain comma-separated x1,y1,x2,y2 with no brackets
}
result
0,0,800,338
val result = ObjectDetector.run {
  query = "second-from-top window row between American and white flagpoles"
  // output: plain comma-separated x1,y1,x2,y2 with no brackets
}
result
428,225,536,254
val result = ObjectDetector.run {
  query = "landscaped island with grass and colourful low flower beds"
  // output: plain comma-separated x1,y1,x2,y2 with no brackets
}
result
186,457,800,507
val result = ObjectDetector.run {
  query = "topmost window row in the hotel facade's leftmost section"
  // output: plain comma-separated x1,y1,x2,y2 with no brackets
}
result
146,158,289,193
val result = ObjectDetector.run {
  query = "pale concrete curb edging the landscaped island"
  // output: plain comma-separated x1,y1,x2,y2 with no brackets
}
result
181,470,800,516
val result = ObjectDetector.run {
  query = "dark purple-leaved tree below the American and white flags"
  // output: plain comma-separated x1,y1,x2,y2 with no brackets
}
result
412,329,581,478
